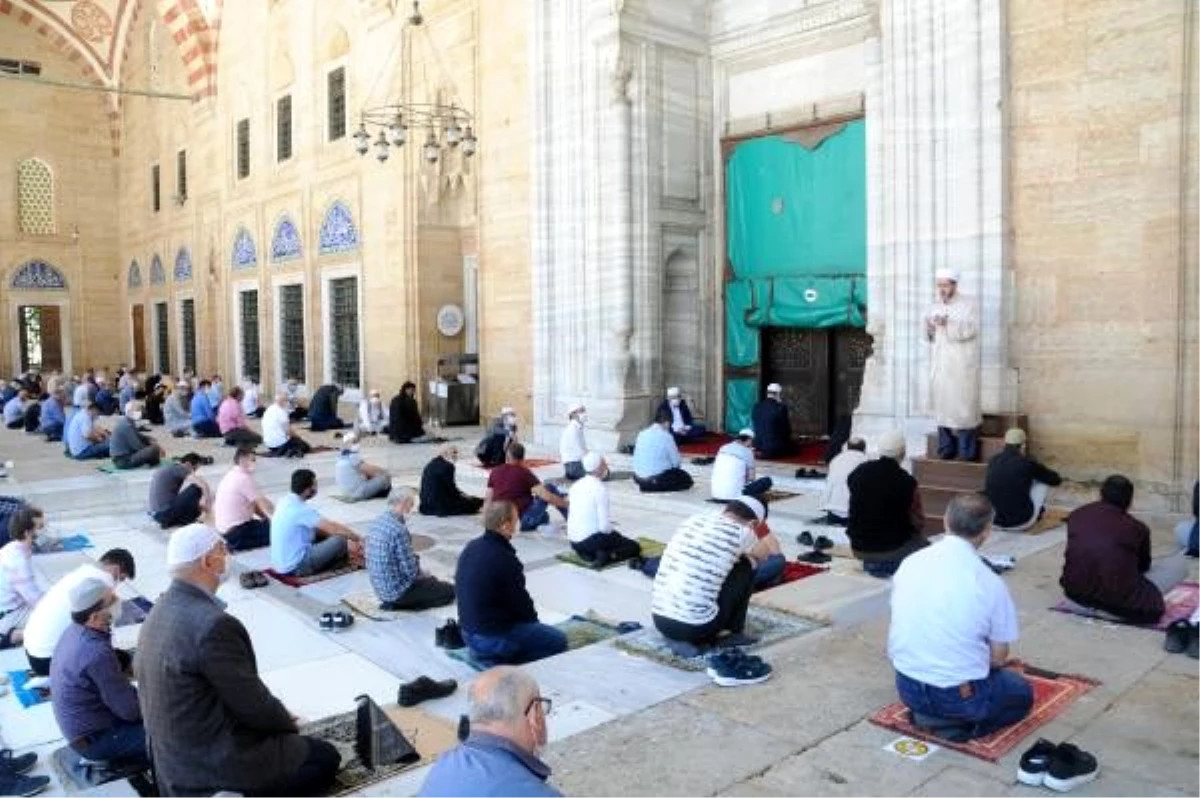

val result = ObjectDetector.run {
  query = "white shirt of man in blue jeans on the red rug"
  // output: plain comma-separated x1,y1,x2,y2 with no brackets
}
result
888,535,1018,688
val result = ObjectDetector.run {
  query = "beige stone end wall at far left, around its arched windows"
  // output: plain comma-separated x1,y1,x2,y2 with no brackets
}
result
0,16,125,374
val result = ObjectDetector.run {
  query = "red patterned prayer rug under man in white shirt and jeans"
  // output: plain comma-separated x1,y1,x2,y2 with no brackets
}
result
870,665,1099,762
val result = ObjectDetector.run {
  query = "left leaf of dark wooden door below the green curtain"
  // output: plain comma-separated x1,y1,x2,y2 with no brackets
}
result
762,328,829,436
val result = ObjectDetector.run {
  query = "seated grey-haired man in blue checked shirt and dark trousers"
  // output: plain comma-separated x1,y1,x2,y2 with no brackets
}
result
364,487,454,610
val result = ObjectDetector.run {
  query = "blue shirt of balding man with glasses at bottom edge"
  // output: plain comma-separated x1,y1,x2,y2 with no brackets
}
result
419,732,563,798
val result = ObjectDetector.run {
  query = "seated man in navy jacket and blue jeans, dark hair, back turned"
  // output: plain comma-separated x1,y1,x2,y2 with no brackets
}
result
454,502,566,665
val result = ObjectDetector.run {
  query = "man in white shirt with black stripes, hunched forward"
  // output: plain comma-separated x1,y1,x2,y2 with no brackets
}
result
650,496,772,653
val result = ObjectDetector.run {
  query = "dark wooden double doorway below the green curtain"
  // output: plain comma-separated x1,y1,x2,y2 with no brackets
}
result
760,326,871,437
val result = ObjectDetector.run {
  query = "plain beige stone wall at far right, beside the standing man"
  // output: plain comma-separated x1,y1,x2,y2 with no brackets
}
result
1008,0,1200,502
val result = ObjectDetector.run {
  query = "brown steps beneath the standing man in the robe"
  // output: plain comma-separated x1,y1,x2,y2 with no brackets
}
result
912,413,1028,534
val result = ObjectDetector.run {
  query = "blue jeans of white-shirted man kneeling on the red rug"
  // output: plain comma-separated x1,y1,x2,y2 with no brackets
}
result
896,668,1033,739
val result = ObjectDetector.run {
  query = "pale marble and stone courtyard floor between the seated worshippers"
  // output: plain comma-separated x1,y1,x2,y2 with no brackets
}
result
0,427,1200,798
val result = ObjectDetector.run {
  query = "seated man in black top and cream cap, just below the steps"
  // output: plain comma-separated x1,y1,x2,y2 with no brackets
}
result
846,430,929,578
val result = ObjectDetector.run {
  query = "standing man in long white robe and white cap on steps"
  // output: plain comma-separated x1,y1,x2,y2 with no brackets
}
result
925,269,983,461
